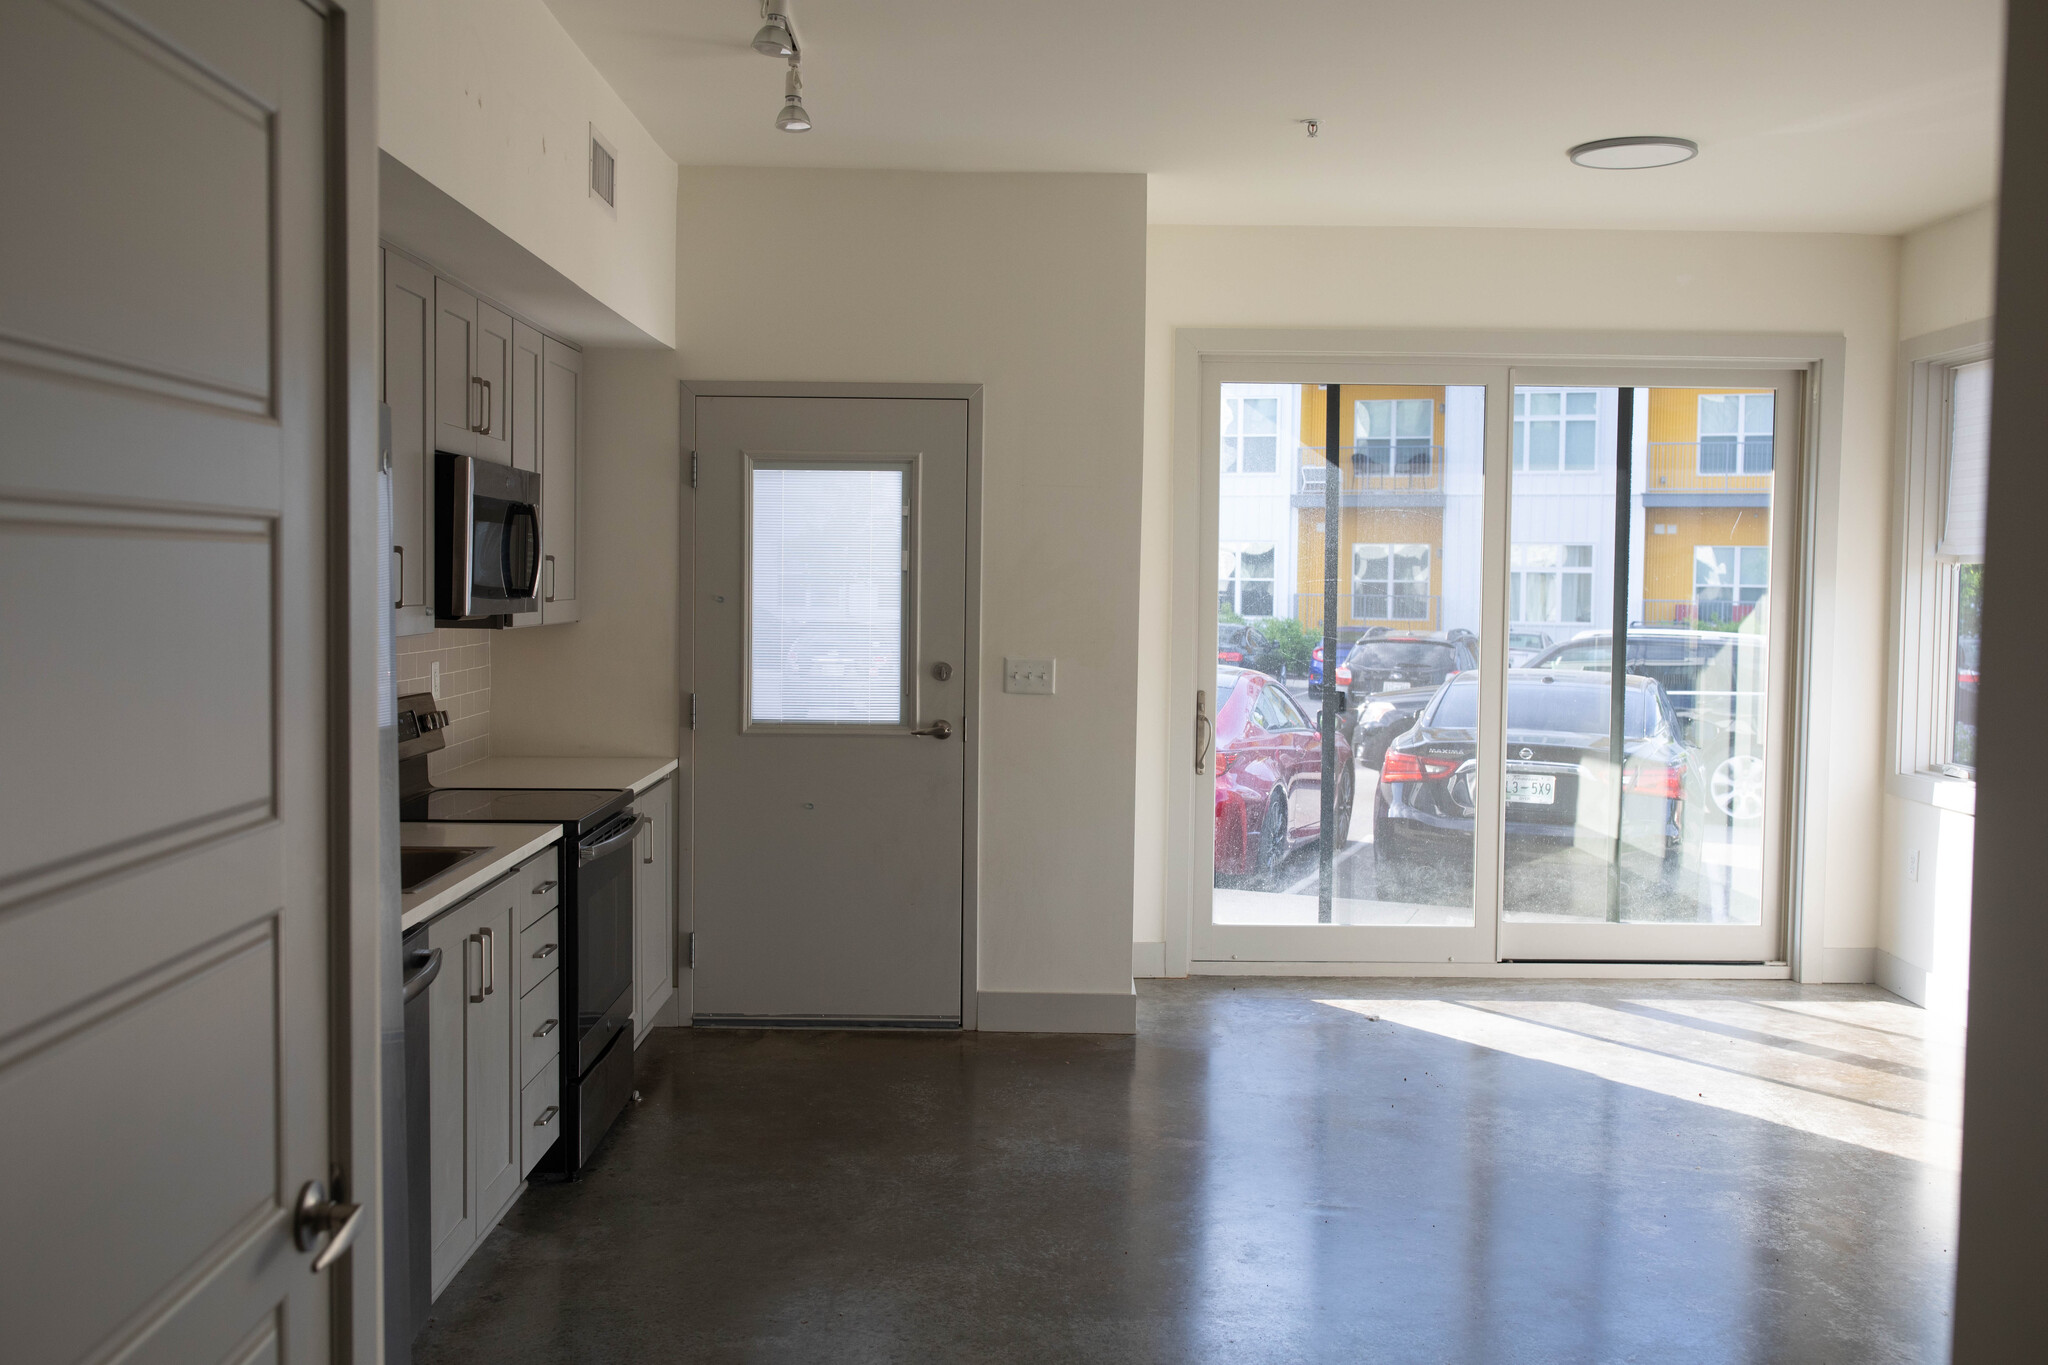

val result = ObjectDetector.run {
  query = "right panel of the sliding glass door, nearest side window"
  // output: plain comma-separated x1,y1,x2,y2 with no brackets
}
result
1501,370,1800,962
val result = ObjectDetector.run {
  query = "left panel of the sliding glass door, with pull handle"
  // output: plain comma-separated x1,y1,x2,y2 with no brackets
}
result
1194,366,1505,962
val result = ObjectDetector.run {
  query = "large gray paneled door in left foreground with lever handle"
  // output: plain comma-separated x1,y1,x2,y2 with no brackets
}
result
0,0,344,1361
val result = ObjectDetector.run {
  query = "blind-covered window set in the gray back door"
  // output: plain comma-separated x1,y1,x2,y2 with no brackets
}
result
745,458,915,729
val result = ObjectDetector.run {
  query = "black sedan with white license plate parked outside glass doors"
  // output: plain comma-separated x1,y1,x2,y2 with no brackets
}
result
1372,669,1698,900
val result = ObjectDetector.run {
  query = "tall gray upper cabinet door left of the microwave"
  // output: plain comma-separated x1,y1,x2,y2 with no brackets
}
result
381,252,434,634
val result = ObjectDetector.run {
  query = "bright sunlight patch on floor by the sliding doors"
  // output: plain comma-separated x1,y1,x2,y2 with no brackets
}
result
1317,997,1962,1171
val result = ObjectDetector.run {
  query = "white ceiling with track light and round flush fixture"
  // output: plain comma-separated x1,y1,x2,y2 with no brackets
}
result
549,0,2003,233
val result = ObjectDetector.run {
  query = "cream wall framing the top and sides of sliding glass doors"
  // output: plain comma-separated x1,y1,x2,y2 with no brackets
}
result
1133,225,1898,980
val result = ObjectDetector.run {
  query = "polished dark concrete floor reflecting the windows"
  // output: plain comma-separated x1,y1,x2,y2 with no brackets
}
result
418,978,1960,1365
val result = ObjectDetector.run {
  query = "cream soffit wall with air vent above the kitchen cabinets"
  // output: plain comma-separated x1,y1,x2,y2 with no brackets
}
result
377,0,676,346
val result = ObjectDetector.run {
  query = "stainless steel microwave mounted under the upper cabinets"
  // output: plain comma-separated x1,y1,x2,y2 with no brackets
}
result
434,450,541,626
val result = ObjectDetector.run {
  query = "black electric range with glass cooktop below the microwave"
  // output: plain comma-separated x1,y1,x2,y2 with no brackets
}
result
397,694,647,1177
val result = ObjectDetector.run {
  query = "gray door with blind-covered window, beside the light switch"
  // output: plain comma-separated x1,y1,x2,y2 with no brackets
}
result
692,397,973,1027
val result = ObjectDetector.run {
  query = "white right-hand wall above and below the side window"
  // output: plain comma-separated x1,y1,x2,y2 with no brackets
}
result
1876,205,1997,1013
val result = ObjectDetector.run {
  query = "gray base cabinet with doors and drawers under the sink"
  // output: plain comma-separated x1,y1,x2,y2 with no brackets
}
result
426,849,559,1293
